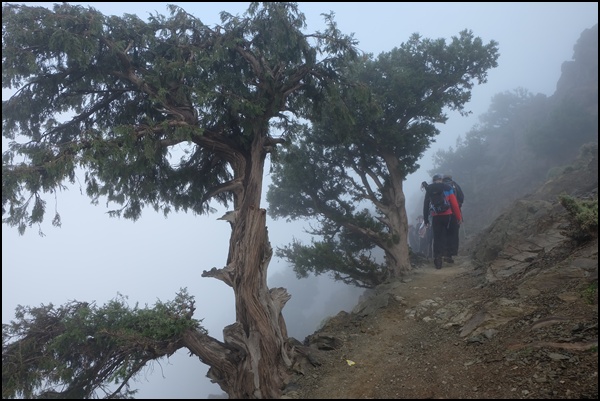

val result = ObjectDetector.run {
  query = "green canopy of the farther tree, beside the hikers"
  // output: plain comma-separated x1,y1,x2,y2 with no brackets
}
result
267,30,499,287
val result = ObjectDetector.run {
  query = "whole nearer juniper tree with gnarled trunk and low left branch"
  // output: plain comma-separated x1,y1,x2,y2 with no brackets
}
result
2,2,356,398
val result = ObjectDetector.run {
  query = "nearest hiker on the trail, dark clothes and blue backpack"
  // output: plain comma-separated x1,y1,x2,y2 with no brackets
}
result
423,174,462,269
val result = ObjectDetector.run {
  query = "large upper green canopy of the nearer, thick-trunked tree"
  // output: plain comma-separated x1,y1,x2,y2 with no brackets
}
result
2,2,356,233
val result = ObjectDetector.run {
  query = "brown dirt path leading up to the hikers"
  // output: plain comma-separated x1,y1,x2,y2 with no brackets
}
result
290,257,496,399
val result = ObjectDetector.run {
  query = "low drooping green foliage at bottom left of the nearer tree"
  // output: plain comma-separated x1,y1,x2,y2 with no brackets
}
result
2,289,206,398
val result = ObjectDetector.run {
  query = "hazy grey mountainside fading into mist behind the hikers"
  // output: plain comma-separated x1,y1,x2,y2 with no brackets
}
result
428,24,598,234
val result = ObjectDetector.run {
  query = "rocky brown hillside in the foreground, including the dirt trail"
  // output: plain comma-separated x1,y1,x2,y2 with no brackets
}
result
285,144,598,399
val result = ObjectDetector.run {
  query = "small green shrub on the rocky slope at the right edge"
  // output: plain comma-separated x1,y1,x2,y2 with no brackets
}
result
558,195,598,241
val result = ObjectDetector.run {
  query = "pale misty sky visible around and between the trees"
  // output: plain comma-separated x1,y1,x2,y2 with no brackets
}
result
2,2,598,398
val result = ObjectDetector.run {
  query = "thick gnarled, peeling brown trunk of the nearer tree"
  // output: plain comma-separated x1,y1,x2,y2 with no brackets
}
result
200,129,293,399
